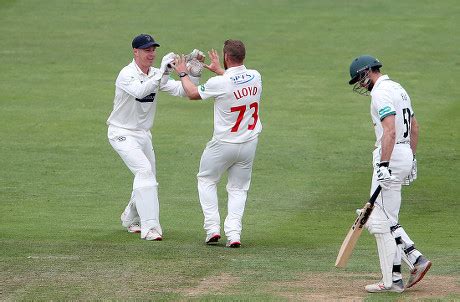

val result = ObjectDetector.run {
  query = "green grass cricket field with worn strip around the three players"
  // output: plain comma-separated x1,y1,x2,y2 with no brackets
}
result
0,0,460,301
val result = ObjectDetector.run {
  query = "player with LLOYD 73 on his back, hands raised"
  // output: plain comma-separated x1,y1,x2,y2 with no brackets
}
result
171,40,262,248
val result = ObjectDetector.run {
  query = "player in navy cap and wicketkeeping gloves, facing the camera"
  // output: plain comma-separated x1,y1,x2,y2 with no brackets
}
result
107,34,204,241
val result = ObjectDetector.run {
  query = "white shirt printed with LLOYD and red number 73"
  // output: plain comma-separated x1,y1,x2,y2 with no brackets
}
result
198,65,262,143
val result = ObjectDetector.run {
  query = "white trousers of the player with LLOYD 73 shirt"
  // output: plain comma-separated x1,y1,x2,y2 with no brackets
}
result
197,138,258,241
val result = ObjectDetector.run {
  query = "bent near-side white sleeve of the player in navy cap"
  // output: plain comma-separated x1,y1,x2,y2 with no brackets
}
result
115,70,158,99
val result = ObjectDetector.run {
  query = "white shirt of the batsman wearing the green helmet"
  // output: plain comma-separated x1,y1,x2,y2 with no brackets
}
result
371,75,414,147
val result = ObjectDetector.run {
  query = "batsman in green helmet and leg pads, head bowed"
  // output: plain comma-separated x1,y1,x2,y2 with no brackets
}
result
349,55,431,293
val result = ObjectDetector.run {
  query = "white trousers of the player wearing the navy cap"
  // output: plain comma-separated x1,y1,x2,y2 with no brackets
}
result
108,125,162,238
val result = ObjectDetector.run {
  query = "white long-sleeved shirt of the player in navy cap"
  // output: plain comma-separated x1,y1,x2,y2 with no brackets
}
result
107,60,185,130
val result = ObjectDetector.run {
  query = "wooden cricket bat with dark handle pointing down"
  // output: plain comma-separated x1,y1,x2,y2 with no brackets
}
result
335,186,382,267
